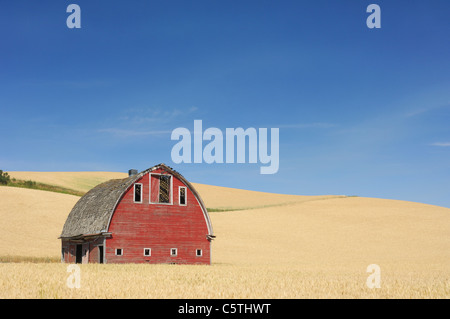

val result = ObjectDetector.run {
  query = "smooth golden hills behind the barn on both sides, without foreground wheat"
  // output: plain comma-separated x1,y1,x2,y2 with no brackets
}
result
0,172,450,267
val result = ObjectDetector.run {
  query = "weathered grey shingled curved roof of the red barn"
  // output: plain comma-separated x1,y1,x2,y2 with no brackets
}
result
59,164,214,238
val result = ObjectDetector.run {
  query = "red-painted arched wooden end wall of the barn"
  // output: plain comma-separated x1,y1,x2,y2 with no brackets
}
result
105,170,210,264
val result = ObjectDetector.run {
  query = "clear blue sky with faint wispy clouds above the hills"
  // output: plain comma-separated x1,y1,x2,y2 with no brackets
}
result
0,0,450,207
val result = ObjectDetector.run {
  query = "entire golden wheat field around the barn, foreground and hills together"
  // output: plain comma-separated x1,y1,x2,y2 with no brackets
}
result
0,173,450,298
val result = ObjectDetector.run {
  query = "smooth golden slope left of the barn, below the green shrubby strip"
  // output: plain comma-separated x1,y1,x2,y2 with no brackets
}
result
0,186,79,257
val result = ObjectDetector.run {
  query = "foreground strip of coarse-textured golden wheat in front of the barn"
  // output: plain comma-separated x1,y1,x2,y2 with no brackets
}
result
0,264,450,299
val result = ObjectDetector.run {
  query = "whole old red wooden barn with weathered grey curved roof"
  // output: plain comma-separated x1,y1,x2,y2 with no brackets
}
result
59,164,215,264
